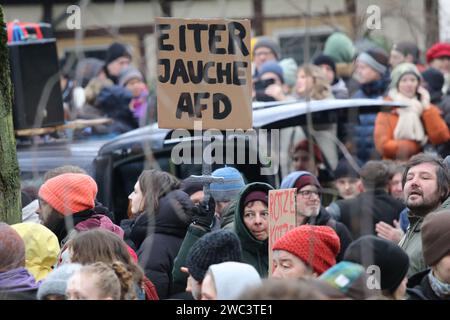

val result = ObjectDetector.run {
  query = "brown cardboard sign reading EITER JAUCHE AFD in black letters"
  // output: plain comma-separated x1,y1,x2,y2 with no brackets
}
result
156,18,252,130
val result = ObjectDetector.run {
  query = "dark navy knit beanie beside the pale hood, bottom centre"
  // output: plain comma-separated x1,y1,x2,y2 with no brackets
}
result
186,230,242,282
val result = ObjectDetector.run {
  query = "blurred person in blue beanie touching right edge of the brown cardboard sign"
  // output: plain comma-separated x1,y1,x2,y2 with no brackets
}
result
253,60,289,101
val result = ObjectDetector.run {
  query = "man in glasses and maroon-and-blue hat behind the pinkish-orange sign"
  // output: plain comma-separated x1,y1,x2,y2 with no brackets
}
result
280,171,352,261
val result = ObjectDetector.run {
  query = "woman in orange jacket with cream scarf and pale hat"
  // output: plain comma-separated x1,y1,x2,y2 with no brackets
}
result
374,63,450,160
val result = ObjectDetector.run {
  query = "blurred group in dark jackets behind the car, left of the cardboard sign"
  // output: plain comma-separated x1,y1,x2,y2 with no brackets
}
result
61,42,156,135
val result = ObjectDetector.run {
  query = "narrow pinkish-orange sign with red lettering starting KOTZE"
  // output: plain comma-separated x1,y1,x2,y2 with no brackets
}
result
269,188,297,277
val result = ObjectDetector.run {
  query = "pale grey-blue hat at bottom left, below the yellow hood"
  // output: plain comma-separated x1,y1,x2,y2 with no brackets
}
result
37,263,82,300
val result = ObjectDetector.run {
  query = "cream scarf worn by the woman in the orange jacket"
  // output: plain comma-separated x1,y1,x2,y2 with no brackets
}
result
389,89,427,145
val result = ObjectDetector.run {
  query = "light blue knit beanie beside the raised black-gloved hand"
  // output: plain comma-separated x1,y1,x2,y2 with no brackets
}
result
210,167,245,202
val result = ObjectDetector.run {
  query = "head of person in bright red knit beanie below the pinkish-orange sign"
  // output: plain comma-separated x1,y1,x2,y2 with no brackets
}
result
272,225,340,279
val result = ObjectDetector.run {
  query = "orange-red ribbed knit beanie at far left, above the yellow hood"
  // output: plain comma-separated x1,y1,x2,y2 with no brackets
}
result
39,173,97,215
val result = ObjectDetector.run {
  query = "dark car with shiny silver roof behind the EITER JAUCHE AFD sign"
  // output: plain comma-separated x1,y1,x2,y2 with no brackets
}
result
18,99,400,220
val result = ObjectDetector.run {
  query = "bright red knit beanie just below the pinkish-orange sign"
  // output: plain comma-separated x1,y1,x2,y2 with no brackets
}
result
272,225,340,275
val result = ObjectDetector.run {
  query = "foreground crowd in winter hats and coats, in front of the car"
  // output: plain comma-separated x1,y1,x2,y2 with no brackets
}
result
0,153,450,300
